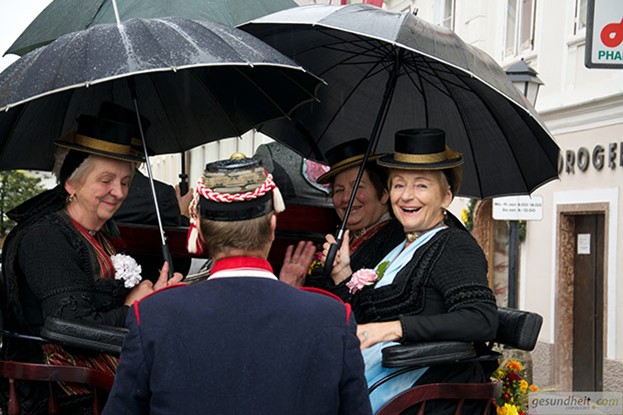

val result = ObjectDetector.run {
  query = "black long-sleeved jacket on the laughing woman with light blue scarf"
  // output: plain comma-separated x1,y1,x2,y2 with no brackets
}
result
351,227,497,342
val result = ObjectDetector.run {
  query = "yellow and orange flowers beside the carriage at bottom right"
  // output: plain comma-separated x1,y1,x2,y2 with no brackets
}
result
493,360,538,415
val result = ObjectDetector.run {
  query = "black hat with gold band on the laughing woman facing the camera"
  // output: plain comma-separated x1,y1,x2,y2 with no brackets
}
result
377,128,463,194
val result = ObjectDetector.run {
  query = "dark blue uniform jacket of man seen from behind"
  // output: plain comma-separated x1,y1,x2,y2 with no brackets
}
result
104,268,371,415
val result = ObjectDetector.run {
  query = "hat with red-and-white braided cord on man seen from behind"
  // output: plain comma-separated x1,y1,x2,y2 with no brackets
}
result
187,153,285,253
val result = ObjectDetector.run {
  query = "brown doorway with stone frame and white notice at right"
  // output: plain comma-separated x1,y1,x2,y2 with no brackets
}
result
555,204,608,391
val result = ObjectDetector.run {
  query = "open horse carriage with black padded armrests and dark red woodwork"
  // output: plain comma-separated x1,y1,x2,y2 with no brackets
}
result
0,199,542,415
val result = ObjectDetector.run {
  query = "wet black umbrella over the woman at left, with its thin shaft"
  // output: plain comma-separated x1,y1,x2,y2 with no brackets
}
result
0,18,321,274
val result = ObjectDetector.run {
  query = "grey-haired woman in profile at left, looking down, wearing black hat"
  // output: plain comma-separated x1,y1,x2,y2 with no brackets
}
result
2,104,182,413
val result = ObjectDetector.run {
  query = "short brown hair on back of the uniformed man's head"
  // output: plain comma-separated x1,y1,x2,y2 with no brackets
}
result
201,212,274,257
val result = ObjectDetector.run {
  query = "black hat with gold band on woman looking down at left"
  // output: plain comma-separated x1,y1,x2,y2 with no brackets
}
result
55,102,149,162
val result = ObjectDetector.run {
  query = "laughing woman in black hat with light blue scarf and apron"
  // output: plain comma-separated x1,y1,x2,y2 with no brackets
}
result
325,129,497,414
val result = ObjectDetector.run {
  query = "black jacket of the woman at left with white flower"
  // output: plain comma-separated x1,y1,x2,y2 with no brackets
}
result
3,190,128,340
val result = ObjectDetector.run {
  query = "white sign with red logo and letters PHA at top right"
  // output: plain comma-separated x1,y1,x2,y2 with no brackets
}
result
584,0,623,69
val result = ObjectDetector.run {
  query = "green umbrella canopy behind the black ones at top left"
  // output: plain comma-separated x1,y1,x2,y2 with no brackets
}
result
6,0,297,55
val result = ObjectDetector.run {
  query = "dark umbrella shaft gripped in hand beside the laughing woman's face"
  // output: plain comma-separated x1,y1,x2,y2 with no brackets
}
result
322,49,403,277
